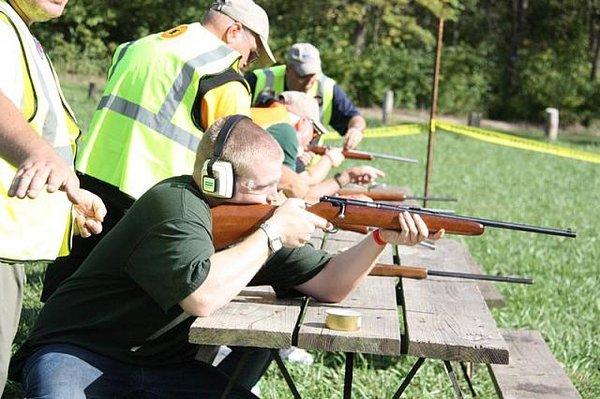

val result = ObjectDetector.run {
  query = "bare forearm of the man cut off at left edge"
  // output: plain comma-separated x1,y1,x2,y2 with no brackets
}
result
0,92,54,167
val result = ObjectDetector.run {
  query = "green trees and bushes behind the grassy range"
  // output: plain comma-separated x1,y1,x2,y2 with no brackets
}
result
35,0,600,125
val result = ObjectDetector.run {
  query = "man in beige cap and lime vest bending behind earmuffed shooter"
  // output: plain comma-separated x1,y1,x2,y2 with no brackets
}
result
42,0,274,300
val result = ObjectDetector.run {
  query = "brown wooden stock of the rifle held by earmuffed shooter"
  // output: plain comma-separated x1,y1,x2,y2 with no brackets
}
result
211,197,484,251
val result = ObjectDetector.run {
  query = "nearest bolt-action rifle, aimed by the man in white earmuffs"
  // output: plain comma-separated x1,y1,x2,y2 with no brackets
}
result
211,196,576,250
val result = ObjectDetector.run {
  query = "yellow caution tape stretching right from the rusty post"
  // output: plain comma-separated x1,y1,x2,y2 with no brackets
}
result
436,121,600,163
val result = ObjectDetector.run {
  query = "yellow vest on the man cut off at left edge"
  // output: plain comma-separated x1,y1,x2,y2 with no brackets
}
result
0,0,79,261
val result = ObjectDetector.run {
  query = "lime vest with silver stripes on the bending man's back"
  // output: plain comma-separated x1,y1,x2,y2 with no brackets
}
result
76,23,246,198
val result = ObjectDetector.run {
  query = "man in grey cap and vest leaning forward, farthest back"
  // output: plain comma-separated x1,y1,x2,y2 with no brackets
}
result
246,43,367,149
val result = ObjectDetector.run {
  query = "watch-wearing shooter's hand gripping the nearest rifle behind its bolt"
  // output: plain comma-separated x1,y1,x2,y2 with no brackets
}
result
267,198,332,248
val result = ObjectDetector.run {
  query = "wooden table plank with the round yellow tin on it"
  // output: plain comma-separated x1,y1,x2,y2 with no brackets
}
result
297,277,400,355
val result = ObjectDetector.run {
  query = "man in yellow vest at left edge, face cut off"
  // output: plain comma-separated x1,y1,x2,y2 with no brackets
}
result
0,0,106,396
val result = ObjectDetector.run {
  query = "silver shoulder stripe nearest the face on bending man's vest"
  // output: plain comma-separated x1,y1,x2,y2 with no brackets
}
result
158,46,231,123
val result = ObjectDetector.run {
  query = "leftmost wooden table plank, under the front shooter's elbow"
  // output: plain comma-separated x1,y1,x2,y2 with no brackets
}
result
189,287,301,348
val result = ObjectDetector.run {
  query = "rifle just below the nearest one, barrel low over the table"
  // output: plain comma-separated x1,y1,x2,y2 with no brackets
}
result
369,263,533,284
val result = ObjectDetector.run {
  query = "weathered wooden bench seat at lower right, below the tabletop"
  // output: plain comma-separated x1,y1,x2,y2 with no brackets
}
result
488,330,581,399
